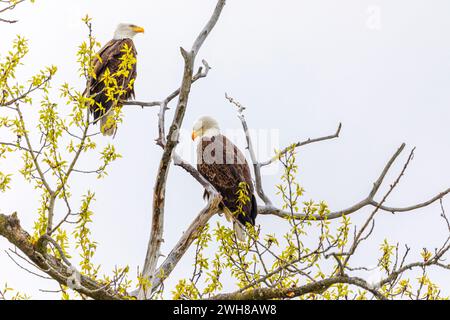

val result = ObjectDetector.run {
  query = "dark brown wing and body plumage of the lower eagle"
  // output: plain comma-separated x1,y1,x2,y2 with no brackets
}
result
197,135,257,225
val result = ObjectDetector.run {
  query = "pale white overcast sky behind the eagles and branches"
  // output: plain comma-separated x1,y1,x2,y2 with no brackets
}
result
0,0,450,298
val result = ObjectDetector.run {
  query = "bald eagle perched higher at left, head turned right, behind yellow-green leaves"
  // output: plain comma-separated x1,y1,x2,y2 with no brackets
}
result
84,23,144,136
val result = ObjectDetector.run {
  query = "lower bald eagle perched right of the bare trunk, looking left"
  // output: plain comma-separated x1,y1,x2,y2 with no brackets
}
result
192,116,257,241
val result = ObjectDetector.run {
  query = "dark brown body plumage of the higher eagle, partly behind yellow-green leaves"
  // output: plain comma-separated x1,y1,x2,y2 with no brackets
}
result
85,39,137,122
